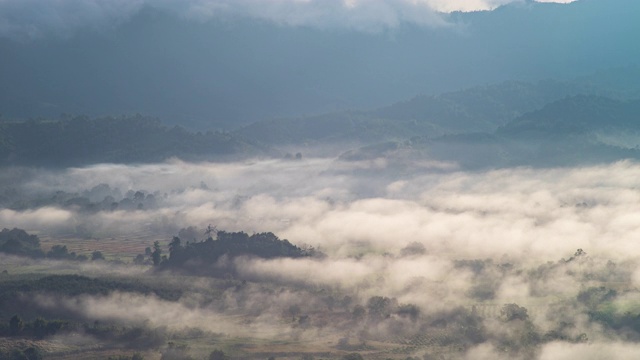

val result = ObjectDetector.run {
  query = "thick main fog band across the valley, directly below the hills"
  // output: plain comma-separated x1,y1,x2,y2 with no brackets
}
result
7,159,640,261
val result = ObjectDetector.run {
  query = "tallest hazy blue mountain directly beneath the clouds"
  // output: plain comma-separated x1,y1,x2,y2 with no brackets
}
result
0,0,640,131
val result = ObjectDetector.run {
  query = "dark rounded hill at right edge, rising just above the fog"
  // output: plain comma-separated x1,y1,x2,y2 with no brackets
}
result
340,95,640,169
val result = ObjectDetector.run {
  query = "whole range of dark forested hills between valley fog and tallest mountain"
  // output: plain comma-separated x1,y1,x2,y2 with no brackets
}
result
0,76,640,169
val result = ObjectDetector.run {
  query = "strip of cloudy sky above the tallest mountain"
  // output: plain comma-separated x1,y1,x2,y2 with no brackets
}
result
0,0,573,38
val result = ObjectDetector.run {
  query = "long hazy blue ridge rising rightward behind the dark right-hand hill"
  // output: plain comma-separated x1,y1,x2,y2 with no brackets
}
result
234,80,620,146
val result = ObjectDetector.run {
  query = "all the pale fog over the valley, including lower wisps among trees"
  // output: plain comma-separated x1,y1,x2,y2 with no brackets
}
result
6,158,640,359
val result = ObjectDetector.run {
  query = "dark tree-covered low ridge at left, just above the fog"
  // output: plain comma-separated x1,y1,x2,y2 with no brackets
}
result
0,115,259,167
